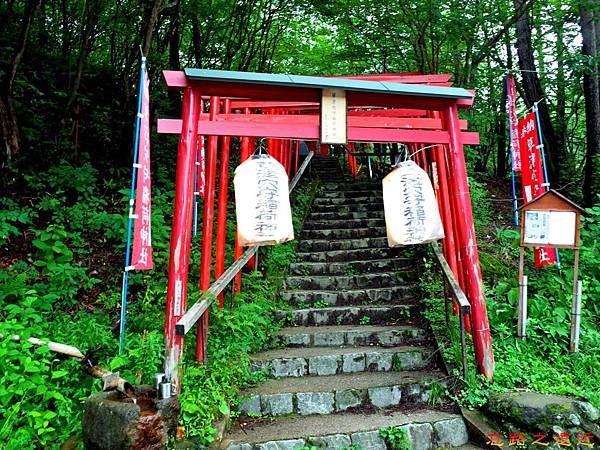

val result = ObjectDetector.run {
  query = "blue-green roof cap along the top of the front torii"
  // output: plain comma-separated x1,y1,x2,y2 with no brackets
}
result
185,68,473,100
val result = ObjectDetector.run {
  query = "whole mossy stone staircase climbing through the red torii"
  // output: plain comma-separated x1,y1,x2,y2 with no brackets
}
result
221,158,468,450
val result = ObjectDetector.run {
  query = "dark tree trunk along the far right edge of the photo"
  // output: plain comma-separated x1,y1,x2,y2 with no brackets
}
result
579,2,600,206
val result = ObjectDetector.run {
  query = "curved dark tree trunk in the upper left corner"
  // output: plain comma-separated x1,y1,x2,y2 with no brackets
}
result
0,0,40,170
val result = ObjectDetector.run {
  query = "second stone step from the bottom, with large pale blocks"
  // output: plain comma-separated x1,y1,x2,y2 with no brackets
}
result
238,372,446,417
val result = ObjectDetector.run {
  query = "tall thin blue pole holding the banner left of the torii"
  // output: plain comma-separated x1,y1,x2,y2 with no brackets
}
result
119,56,146,354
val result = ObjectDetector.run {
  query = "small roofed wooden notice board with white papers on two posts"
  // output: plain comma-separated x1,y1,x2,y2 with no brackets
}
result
517,189,584,352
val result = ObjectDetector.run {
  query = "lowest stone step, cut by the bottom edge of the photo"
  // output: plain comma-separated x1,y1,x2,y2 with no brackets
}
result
221,408,469,450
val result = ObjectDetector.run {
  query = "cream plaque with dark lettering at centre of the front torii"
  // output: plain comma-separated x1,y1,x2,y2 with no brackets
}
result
321,89,348,144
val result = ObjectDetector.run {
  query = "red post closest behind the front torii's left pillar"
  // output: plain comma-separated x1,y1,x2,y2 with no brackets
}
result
196,97,219,362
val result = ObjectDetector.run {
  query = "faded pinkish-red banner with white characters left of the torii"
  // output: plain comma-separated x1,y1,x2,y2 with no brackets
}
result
131,73,154,270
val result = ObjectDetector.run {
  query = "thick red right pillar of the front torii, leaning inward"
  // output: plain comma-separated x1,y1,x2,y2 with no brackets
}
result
444,104,494,379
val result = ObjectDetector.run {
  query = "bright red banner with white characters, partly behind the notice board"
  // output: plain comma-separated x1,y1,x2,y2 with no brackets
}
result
518,112,556,268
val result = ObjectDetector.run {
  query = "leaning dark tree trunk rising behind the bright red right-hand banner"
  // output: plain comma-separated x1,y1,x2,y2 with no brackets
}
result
514,0,562,183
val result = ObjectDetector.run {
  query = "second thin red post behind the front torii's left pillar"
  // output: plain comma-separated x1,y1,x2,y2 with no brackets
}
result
215,99,231,309
